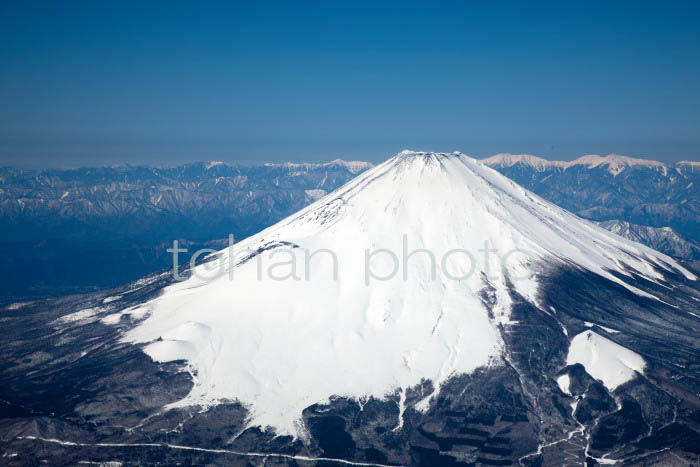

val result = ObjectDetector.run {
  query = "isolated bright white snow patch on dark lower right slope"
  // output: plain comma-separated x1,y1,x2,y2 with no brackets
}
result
566,331,646,391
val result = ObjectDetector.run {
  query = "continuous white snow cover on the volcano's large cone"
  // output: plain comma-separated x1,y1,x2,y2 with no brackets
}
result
117,151,695,436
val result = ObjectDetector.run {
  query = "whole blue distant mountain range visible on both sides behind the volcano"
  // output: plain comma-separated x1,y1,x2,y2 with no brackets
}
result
0,154,700,299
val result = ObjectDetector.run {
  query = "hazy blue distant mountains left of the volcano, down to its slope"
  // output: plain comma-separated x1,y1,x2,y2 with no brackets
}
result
0,160,372,300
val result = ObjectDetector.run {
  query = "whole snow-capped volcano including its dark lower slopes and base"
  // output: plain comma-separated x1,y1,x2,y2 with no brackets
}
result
0,151,700,465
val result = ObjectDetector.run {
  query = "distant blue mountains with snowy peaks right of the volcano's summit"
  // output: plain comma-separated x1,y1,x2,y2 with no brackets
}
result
483,154,700,249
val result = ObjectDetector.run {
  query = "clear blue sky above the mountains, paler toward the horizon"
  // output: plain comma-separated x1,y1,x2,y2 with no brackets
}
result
0,0,700,166
